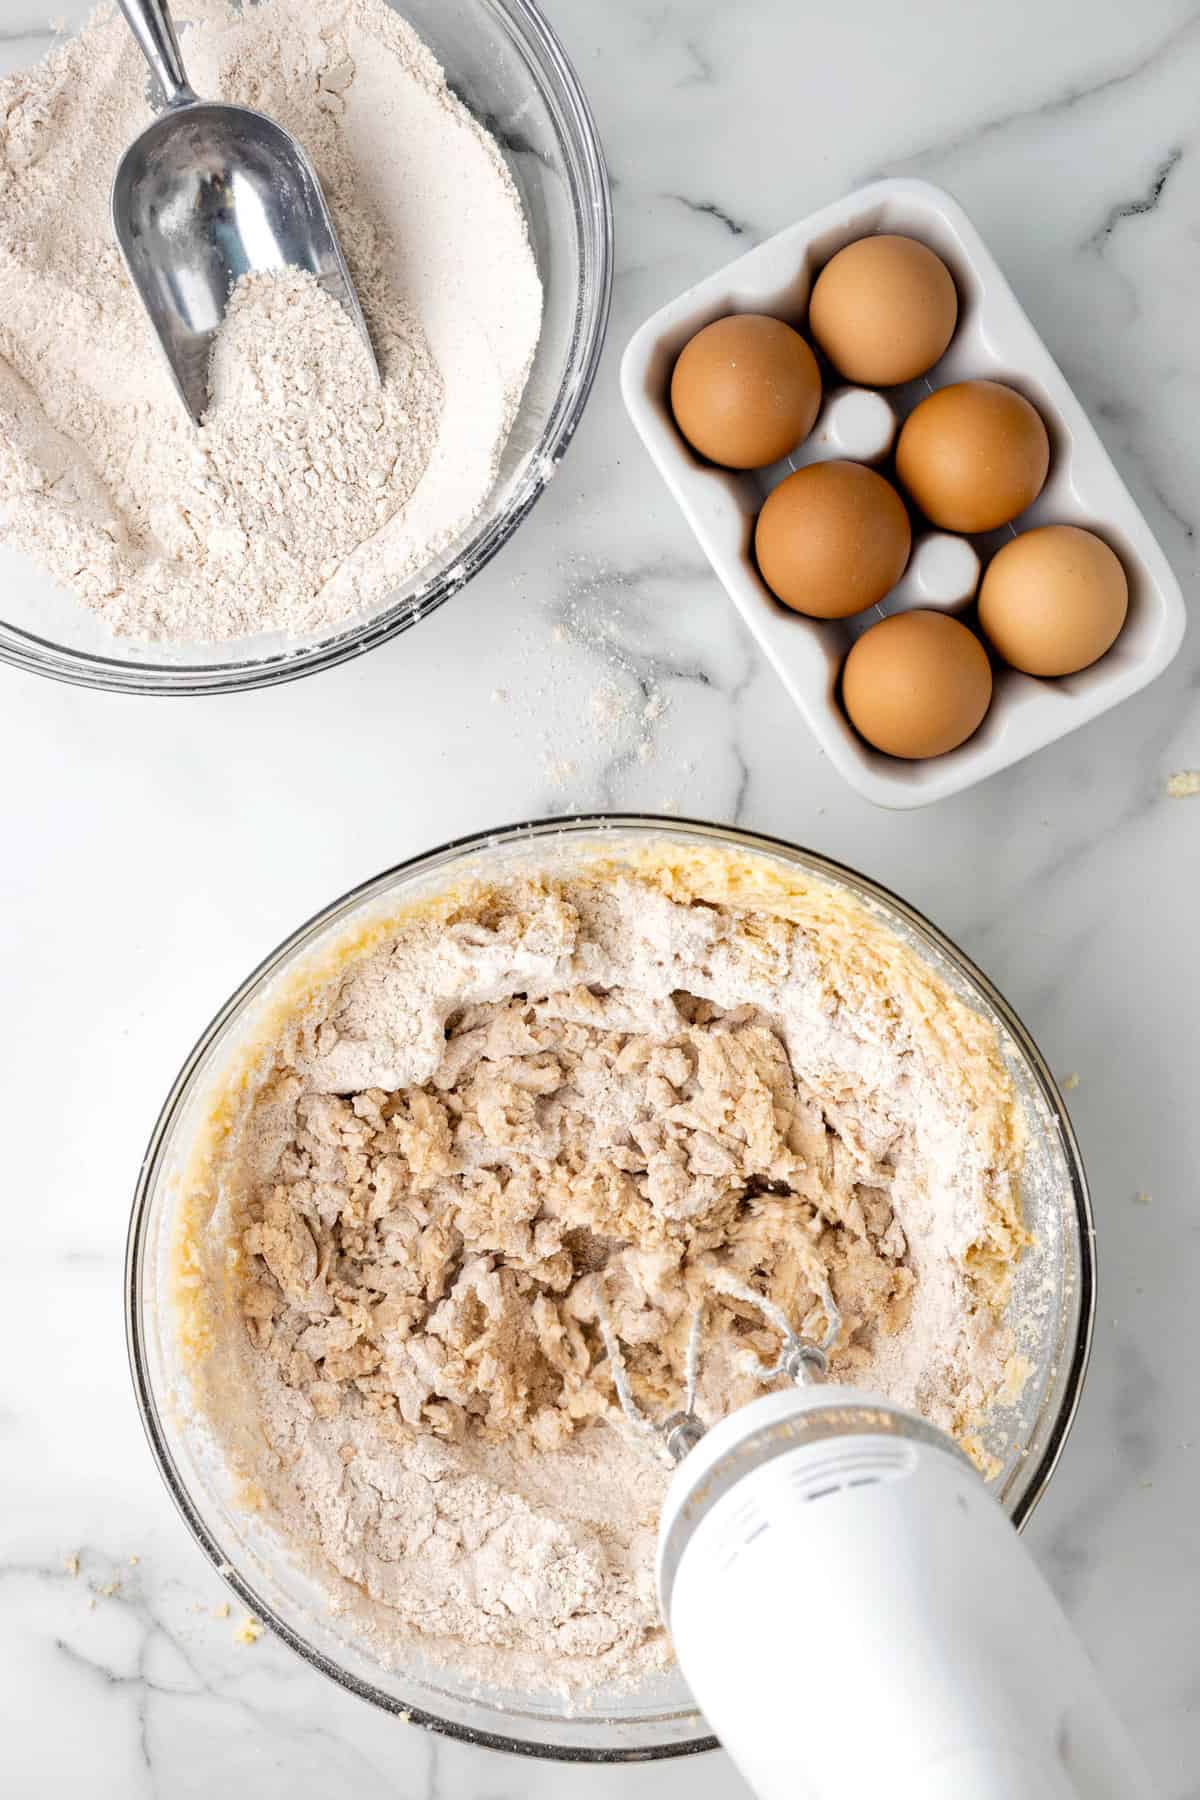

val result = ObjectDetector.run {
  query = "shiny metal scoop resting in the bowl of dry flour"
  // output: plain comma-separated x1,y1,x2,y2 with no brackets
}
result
112,0,380,425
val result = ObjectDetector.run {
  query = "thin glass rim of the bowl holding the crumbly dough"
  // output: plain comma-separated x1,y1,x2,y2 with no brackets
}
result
124,812,1096,1764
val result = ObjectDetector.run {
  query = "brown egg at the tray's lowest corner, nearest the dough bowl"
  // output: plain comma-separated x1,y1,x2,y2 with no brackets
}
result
842,612,991,761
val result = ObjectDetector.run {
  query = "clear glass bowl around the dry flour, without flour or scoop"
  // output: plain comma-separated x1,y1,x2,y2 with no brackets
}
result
0,0,612,693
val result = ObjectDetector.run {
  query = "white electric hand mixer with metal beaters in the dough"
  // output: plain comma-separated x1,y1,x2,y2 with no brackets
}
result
601,1282,1151,1800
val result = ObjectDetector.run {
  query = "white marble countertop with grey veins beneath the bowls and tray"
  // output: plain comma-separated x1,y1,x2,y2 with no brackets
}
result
0,0,1200,1800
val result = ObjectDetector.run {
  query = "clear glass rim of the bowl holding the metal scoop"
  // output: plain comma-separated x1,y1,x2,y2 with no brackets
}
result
0,0,613,698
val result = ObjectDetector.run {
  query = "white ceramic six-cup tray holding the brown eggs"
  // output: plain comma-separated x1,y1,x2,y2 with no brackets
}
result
621,180,1184,806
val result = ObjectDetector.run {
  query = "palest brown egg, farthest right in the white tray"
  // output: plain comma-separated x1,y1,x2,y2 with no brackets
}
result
979,526,1130,675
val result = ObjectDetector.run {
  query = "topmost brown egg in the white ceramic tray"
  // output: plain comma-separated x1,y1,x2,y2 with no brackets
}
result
808,234,959,387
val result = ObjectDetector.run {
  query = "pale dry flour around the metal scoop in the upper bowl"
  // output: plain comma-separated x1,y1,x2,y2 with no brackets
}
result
0,0,542,641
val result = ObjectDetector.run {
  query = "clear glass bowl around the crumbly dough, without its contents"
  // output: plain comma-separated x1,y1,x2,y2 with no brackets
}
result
126,815,1094,1762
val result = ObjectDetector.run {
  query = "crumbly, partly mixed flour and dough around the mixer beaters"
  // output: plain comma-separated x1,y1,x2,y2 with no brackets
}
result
176,850,1027,1692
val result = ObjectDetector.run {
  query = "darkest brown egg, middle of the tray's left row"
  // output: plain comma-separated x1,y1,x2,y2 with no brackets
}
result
754,463,912,619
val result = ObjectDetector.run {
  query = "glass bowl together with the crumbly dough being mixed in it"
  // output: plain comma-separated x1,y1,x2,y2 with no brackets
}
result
128,817,1092,1759
